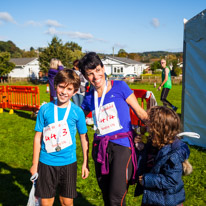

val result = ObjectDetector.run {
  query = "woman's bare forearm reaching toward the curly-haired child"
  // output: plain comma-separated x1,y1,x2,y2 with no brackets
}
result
126,93,148,121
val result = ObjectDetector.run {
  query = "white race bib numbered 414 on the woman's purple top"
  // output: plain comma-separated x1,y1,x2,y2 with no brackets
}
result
92,102,122,135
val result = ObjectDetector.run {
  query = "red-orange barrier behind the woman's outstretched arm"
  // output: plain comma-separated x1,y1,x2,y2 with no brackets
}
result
130,89,151,126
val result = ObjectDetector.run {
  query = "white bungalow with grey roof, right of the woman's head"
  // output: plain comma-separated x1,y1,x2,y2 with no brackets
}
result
102,56,147,76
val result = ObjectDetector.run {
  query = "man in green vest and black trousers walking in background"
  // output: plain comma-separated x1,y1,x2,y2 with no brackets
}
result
158,59,178,112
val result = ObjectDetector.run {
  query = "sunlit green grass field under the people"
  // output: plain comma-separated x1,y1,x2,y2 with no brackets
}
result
0,85,206,206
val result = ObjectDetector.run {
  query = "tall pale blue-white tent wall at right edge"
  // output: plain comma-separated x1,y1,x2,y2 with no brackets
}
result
182,9,206,147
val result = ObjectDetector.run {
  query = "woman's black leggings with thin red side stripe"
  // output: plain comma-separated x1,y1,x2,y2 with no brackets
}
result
93,142,133,206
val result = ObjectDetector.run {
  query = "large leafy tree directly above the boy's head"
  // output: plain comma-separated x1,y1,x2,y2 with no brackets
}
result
39,36,83,73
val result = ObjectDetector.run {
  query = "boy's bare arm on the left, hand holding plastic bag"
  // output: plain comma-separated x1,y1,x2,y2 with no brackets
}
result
30,132,42,175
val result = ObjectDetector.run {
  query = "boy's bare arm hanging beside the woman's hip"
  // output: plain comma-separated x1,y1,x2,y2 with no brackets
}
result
80,134,89,179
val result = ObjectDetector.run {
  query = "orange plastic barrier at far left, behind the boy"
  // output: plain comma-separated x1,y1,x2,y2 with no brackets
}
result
0,86,40,112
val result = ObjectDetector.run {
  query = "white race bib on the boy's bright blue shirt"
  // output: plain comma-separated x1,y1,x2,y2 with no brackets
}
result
43,120,72,153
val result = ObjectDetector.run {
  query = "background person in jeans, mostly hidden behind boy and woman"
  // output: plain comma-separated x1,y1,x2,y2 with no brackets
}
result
72,59,87,107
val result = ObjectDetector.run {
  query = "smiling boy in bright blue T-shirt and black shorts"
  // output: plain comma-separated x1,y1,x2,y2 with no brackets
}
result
30,69,89,206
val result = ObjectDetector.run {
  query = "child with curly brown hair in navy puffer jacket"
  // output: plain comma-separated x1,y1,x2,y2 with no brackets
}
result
136,106,192,206
